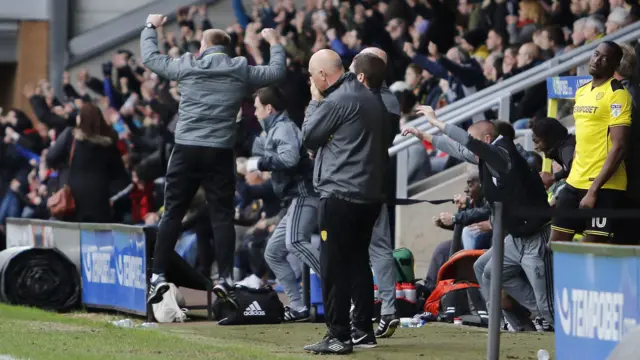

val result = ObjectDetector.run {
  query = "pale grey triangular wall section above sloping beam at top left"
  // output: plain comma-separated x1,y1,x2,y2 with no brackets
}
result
69,0,154,36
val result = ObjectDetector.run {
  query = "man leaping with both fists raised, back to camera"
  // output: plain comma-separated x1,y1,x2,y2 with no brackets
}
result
140,15,286,304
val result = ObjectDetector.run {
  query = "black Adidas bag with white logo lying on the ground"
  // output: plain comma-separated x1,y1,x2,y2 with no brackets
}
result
213,286,284,325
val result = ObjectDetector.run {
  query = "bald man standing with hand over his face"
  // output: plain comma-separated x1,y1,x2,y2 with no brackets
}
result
302,50,387,354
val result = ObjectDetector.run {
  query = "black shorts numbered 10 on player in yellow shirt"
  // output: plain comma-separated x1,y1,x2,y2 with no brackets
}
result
551,184,625,237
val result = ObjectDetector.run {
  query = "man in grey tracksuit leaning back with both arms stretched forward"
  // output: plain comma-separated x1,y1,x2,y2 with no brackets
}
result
402,106,554,327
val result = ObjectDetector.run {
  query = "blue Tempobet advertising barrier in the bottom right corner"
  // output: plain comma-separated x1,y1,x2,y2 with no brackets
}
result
551,243,640,360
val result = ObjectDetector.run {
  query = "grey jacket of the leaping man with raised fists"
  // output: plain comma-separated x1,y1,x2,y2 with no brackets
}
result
140,28,287,149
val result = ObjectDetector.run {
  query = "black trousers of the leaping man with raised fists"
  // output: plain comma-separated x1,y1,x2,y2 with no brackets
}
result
153,144,236,278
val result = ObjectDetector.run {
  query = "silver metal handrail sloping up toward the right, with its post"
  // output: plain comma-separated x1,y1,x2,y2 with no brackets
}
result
389,22,640,199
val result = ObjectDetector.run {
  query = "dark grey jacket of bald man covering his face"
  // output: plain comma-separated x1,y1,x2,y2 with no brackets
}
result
302,73,388,203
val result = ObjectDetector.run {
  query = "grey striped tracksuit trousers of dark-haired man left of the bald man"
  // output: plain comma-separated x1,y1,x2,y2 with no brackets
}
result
264,197,320,310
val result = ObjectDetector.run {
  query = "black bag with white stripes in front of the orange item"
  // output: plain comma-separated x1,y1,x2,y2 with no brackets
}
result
439,287,489,327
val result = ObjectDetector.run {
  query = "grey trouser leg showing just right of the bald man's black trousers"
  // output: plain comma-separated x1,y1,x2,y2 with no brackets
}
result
369,204,396,315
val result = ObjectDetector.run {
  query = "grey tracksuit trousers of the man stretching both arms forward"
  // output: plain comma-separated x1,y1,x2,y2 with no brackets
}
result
473,226,554,330
